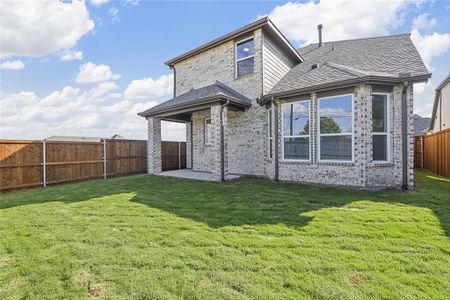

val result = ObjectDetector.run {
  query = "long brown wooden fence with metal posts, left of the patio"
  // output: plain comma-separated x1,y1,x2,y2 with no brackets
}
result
0,140,147,191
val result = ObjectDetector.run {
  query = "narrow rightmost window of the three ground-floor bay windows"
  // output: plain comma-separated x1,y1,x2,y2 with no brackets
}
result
372,94,389,161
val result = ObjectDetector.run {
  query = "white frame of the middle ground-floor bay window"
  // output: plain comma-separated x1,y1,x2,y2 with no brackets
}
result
317,93,355,163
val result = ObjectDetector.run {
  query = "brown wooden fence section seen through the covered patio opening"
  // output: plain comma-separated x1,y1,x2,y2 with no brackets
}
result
161,141,186,171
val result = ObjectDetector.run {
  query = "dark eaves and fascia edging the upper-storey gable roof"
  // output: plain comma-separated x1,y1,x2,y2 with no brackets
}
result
165,17,302,66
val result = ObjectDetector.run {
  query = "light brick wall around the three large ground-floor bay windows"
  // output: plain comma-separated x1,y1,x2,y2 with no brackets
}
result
266,84,413,188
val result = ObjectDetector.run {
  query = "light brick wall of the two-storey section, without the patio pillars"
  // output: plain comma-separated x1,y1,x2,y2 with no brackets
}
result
175,30,267,176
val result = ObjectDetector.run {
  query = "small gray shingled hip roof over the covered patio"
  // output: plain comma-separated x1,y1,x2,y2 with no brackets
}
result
138,81,252,117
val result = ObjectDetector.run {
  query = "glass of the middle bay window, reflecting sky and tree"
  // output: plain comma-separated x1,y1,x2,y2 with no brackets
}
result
319,95,353,161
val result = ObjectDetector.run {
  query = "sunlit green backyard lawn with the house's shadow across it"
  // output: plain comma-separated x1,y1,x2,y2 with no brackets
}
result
0,172,450,299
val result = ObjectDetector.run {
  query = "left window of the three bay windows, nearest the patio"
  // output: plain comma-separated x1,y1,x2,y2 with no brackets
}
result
282,100,309,160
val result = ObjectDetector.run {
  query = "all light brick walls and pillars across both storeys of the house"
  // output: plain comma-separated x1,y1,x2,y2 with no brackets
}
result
148,30,413,188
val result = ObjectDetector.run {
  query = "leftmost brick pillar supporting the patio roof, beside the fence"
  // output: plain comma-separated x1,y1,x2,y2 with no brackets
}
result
147,117,162,174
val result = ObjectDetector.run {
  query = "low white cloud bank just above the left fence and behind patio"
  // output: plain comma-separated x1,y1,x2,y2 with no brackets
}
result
0,81,185,140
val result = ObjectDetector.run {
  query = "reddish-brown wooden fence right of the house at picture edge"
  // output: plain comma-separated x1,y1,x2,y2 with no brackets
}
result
414,129,450,177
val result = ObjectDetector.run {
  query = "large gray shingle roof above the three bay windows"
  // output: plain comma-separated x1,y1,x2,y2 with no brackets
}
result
269,34,429,94
